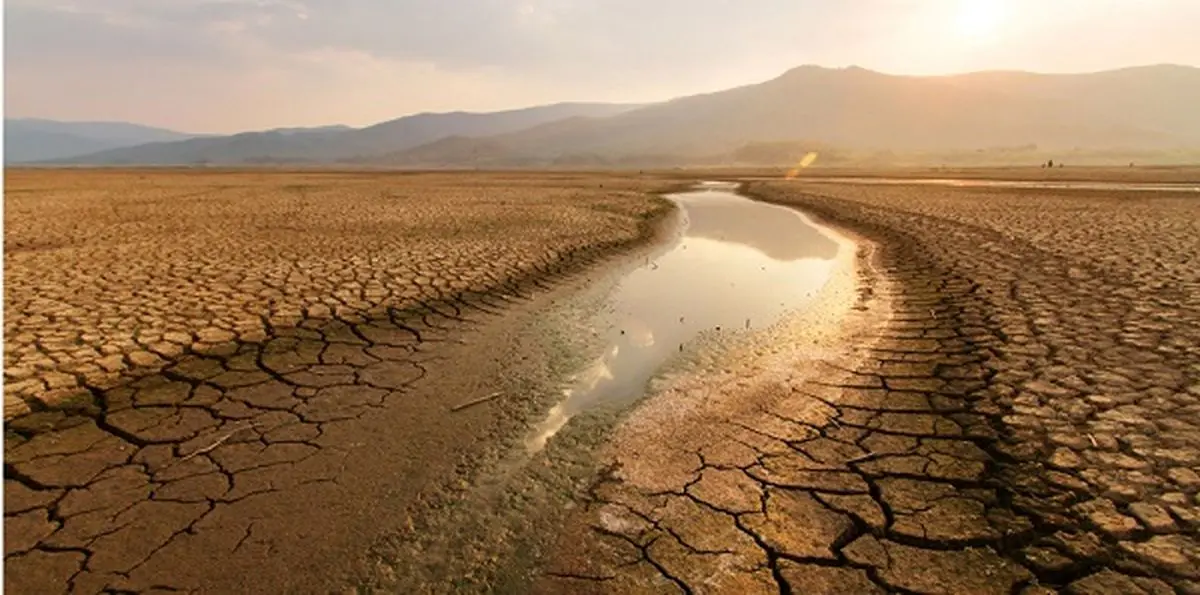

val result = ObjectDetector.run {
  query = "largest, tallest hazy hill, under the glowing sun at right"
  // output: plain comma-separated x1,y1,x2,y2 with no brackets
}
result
378,66,1200,166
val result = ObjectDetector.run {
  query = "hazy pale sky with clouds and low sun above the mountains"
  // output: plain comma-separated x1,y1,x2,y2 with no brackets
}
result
4,0,1200,132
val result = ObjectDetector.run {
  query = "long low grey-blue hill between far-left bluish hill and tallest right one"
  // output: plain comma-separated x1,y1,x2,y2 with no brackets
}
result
54,103,637,164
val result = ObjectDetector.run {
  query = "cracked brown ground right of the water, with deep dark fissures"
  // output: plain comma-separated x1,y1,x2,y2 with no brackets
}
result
540,181,1200,595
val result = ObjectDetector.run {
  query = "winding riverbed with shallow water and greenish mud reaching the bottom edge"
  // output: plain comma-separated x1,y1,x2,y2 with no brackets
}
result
360,184,854,591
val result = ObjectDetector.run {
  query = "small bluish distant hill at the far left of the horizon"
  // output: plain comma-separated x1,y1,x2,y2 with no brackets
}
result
4,118,192,163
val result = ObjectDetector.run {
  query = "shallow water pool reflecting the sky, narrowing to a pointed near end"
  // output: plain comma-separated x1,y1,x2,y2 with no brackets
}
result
526,182,838,452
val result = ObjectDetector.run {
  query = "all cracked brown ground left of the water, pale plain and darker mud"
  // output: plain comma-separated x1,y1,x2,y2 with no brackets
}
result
4,170,671,593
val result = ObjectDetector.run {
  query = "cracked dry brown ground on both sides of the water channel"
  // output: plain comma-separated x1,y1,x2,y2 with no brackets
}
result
5,170,1200,595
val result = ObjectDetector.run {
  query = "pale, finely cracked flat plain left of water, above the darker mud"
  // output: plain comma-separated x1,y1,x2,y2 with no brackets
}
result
5,170,676,419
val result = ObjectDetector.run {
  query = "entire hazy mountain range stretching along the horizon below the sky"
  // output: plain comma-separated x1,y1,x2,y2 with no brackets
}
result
5,65,1200,168
